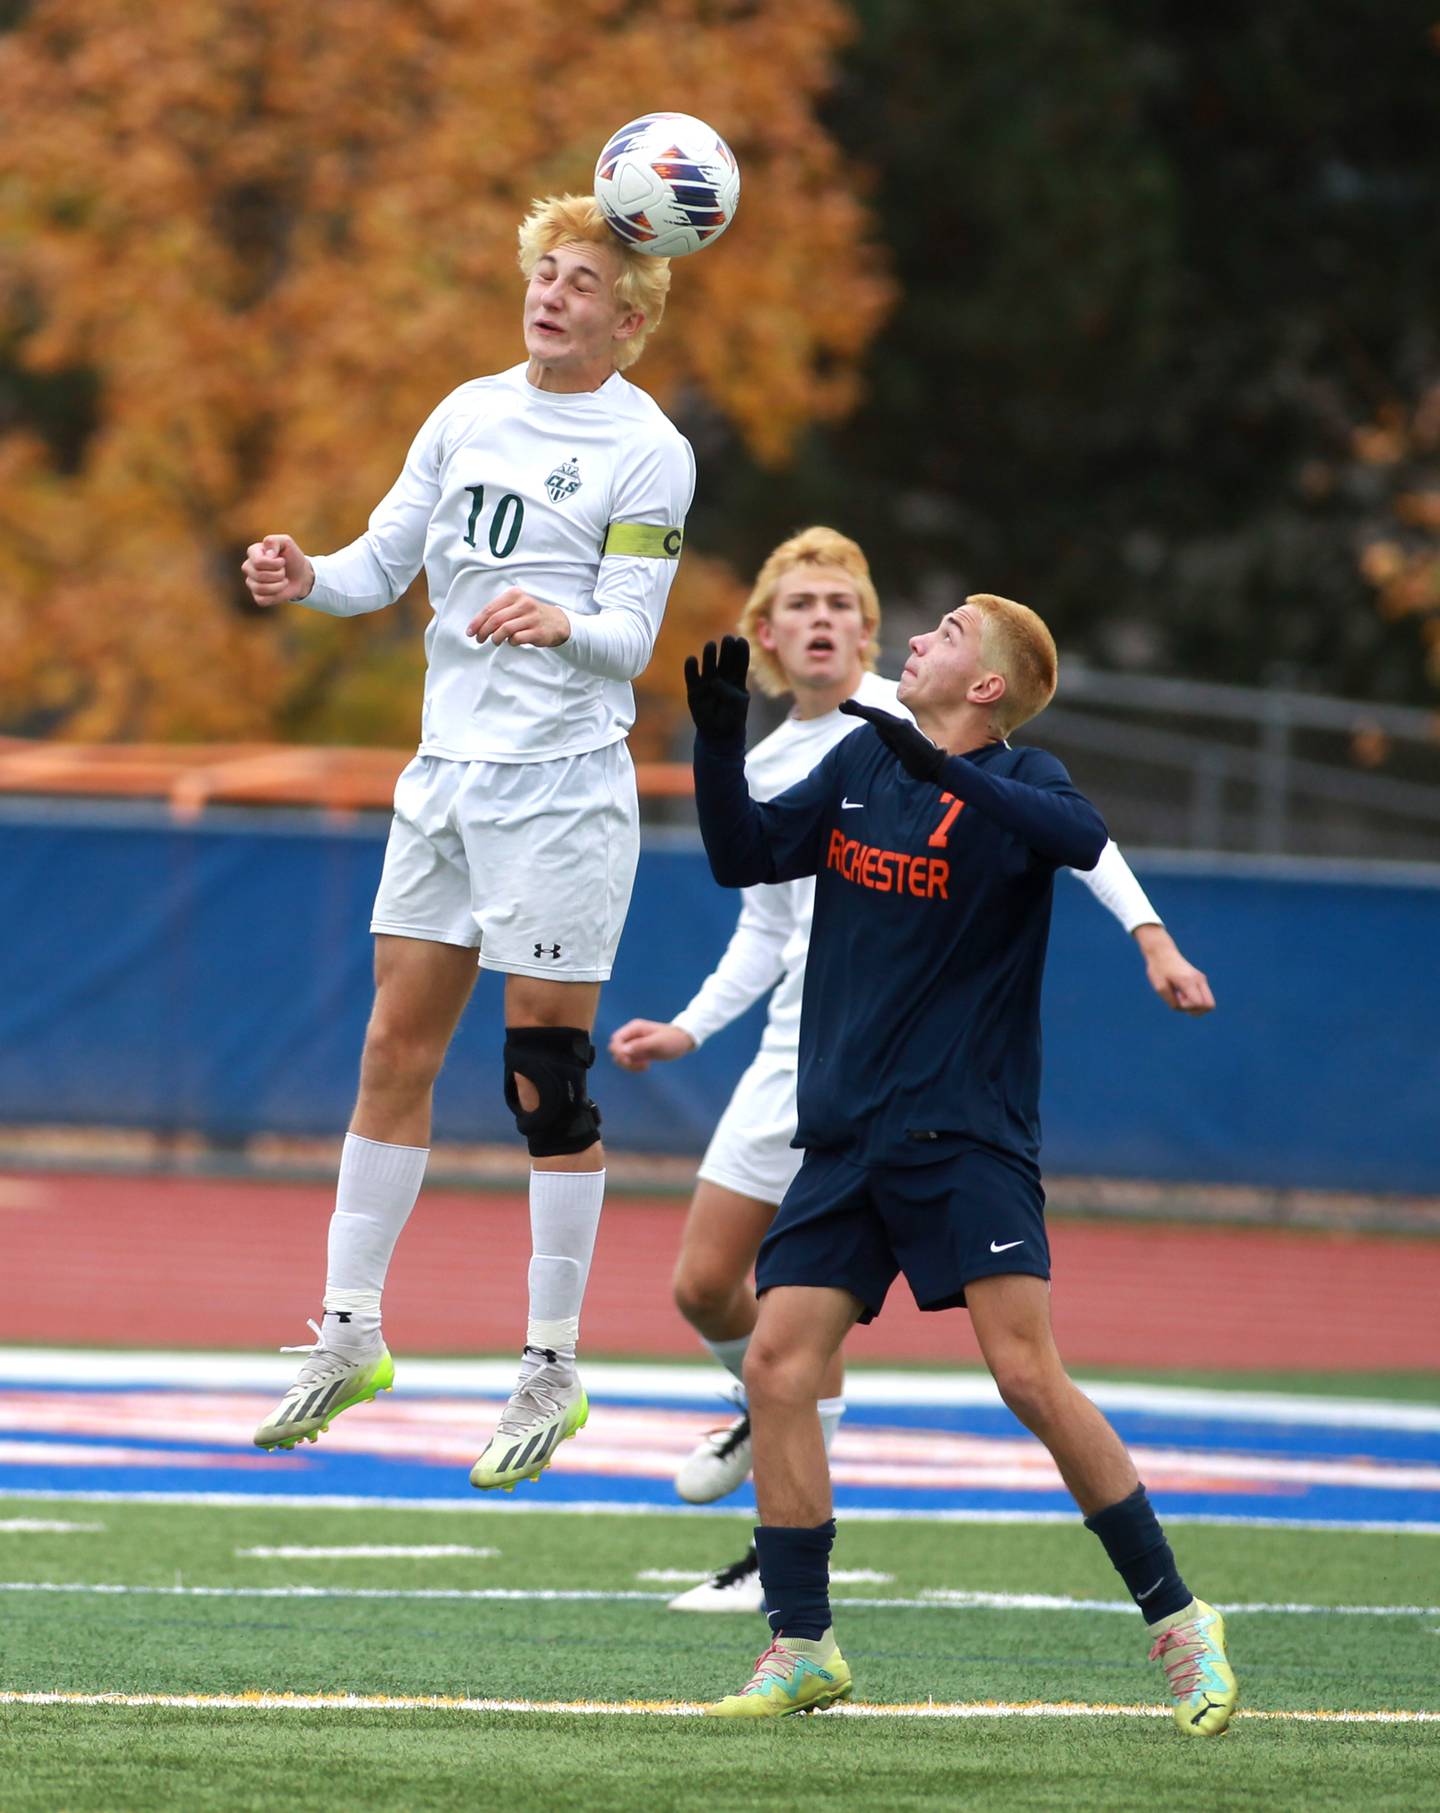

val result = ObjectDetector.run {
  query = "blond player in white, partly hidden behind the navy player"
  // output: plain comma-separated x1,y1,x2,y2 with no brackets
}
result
609,528,1215,1612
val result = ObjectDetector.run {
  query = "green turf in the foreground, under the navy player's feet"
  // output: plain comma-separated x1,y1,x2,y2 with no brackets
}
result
0,1499,1440,1813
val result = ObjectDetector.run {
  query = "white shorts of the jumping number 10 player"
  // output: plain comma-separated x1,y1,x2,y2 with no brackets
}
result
370,743,640,983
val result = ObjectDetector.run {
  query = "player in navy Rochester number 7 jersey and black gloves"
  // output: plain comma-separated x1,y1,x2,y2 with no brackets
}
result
686,593,1237,1737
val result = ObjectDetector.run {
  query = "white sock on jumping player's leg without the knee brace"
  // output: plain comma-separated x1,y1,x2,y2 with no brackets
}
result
325,1133,430,1354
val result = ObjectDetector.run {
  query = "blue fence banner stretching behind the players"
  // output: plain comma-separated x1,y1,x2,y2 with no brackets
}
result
0,801,1440,1193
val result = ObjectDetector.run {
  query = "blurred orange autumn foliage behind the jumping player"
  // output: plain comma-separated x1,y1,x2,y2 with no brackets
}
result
0,0,887,752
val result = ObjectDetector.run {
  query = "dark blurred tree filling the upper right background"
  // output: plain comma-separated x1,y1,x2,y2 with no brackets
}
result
681,0,1440,700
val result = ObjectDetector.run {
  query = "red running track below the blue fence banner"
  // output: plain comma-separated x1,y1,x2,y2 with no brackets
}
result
0,1173,1440,1371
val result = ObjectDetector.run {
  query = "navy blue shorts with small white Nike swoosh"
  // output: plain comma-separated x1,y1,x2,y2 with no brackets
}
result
754,1142,1050,1322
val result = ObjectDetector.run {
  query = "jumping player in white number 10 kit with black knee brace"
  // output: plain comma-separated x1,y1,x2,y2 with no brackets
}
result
243,196,695,1490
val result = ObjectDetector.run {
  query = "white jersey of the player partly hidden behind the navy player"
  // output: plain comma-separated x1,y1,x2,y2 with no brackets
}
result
671,674,1161,1068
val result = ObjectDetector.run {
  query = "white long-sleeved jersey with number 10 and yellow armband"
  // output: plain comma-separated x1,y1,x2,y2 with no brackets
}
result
301,364,695,761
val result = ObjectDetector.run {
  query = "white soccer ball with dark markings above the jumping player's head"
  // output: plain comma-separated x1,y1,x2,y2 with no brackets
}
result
595,114,740,257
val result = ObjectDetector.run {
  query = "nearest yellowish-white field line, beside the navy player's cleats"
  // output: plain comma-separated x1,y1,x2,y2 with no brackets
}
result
0,1690,1440,1724
